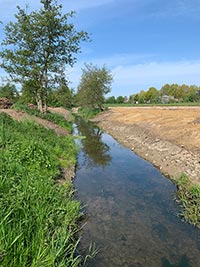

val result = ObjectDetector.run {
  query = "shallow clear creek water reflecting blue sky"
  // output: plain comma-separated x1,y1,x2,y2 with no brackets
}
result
74,118,200,267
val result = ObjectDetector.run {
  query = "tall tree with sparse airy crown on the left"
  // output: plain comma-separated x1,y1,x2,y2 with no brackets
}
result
0,0,88,111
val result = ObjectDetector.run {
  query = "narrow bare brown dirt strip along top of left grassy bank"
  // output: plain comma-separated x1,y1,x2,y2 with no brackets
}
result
0,109,68,135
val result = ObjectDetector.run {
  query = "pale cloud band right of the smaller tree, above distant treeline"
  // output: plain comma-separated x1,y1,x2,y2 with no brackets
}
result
112,60,200,94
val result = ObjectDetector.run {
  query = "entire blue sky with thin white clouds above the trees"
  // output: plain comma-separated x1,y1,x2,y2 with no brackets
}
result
0,0,200,97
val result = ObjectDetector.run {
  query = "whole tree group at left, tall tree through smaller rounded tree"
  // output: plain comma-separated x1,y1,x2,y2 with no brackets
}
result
0,0,112,112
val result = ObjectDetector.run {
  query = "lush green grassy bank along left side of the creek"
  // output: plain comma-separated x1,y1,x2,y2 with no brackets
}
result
0,113,81,267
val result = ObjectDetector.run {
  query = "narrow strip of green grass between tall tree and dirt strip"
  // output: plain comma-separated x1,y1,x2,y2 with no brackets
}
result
14,104,72,132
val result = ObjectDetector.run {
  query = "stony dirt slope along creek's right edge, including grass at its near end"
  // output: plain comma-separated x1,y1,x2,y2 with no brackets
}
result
91,110,200,227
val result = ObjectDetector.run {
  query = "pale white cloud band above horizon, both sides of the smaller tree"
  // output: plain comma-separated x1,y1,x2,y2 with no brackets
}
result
67,55,200,96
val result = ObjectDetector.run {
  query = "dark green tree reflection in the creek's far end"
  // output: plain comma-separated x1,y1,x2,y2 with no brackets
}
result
76,117,111,166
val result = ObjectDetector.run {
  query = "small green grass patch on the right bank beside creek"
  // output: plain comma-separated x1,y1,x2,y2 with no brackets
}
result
175,174,200,228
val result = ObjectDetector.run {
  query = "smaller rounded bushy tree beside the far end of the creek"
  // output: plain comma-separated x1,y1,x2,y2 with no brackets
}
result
77,64,113,110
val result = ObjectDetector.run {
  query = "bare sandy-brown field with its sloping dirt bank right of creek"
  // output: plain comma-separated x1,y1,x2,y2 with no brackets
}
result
94,107,200,184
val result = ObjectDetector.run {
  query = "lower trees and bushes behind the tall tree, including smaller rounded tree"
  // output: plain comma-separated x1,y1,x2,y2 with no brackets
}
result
0,64,112,110
